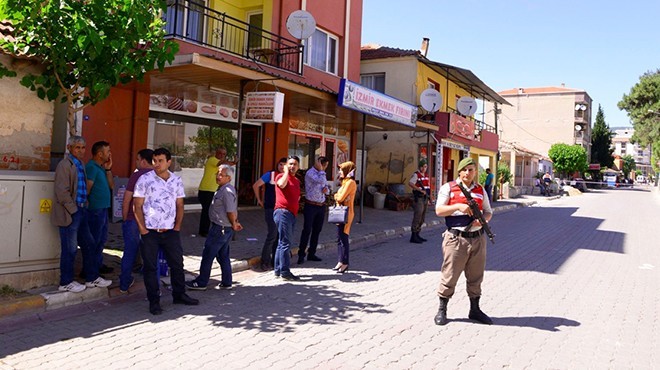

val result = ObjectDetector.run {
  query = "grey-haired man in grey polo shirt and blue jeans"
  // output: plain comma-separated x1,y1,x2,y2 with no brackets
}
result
186,164,243,290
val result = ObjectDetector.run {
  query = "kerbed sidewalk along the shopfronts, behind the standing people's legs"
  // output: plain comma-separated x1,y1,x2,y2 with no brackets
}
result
0,195,559,321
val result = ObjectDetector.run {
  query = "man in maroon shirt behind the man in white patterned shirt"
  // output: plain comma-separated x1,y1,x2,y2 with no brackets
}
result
119,149,154,293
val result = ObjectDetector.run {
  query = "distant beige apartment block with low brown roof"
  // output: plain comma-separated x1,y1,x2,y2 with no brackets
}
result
485,84,592,162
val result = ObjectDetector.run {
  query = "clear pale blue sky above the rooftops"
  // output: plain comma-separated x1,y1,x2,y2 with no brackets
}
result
362,0,660,127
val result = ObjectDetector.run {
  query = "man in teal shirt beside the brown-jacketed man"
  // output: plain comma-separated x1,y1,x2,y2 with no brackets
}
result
81,141,114,288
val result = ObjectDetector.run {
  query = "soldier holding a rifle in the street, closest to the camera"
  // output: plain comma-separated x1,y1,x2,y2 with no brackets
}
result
435,157,493,325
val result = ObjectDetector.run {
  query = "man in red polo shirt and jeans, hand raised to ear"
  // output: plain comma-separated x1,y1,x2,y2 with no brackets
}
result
273,155,300,280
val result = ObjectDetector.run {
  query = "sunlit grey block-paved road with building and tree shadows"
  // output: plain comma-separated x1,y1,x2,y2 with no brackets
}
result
0,189,660,369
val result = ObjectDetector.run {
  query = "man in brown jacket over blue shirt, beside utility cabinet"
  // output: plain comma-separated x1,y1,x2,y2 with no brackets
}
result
50,136,89,293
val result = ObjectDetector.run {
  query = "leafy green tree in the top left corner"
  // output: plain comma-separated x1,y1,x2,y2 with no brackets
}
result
0,0,178,134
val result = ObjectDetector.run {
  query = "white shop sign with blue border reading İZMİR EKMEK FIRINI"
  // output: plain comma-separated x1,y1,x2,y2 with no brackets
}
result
337,78,417,127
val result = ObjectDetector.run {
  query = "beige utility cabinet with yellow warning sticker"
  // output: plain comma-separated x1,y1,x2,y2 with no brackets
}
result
0,171,60,275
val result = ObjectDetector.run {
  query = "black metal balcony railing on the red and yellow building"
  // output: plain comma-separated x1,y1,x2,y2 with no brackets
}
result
164,0,303,75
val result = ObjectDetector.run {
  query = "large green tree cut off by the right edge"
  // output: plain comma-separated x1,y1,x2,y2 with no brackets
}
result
618,70,660,172
